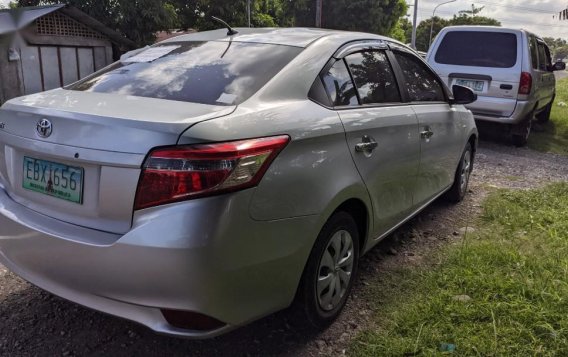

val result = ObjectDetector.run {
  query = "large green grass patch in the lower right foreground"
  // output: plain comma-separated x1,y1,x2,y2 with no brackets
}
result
350,183,568,356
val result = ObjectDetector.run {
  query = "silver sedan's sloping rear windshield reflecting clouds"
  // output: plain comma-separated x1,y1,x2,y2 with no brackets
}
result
67,42,302,105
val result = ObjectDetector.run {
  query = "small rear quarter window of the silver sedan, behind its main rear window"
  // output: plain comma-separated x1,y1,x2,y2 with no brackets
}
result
322,60,359,106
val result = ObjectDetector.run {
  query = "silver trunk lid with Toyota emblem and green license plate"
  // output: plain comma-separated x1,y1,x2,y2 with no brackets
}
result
0,90,235,234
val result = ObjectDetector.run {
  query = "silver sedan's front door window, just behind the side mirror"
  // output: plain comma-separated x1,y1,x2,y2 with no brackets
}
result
394,52,445,102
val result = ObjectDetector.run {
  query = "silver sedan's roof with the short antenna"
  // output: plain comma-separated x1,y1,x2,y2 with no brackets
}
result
161,27,397,48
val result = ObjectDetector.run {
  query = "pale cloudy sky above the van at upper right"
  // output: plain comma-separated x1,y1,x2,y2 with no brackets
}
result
0,0,568,40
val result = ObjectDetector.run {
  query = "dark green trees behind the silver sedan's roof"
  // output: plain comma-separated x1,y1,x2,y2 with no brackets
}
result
18,0,407,45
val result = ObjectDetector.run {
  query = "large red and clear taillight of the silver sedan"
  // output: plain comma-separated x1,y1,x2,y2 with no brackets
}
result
134,135,290,209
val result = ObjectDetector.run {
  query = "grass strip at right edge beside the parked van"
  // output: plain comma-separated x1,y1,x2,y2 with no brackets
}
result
528,78,568,155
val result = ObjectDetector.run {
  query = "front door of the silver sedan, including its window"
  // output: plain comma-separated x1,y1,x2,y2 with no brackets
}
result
393,49,465,207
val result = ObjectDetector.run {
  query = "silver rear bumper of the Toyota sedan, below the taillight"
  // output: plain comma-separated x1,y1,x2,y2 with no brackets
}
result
0,186,317,338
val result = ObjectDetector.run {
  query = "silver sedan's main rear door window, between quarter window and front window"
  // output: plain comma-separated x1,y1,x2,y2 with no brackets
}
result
345,51,401,104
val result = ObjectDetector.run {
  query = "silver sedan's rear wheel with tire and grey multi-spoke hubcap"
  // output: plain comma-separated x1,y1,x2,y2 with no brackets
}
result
297,211,359,329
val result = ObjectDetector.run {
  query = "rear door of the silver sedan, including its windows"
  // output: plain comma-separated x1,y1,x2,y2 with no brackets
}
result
322,46,420,237
